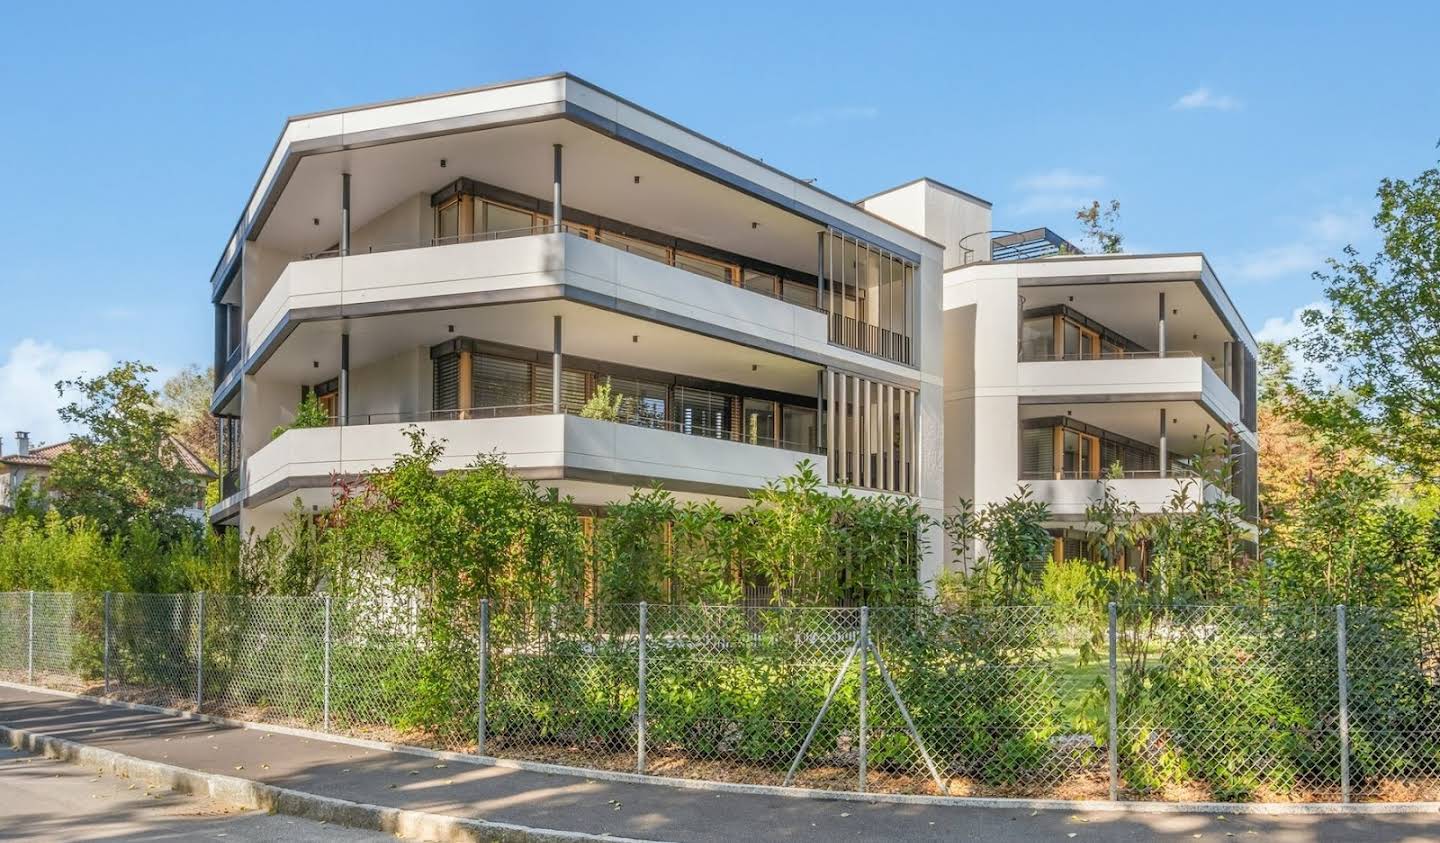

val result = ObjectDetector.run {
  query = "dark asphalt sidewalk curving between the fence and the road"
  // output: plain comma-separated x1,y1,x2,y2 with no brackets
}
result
0,686,1440,843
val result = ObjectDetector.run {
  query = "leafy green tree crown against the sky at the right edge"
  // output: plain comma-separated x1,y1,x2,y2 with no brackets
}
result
1297,157,1440,481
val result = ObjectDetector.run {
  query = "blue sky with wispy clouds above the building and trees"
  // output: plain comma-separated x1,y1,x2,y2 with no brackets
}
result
0,1,1440,450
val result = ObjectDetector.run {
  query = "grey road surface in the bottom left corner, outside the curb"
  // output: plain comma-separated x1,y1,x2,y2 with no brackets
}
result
0,749,395,843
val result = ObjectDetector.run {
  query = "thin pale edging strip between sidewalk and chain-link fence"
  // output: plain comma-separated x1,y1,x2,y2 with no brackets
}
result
0,680,1440,812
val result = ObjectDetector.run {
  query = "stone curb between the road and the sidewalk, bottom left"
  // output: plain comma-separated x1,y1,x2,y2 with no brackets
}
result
0,725,673,843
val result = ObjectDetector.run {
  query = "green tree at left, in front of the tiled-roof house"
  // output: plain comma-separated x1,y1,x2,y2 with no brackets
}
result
49,362,200,538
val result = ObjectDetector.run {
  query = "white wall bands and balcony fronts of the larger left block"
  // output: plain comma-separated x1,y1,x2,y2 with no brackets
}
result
218,76,950,581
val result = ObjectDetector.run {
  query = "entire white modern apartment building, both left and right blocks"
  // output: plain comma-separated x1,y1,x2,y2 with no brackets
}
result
210,73,1254,581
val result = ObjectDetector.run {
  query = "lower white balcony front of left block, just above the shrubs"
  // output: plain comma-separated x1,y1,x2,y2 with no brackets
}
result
246,405,825,506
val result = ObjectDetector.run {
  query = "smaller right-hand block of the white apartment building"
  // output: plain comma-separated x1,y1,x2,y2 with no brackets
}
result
861,179,1259,559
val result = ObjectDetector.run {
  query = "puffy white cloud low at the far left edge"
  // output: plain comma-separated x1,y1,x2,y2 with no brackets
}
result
0,339,114,452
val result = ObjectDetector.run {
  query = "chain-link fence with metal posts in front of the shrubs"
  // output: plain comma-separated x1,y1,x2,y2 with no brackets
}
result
0,592,1440,801
